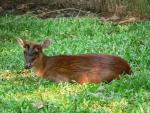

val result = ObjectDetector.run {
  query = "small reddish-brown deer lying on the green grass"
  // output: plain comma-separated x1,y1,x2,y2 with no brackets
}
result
17,38,132,84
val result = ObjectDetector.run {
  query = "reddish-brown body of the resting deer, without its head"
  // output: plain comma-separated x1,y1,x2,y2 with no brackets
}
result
35,54,131,83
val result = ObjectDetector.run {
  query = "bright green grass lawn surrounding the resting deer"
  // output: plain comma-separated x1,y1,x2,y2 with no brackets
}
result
0,16,150,113
